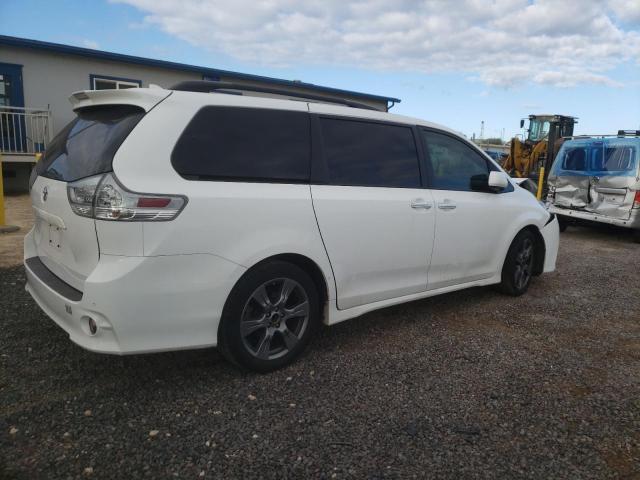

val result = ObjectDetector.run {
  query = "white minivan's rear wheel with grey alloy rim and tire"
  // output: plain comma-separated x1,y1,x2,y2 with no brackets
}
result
218,261,320,373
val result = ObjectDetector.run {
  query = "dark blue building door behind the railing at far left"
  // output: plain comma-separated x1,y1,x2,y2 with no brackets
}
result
0,63,27,152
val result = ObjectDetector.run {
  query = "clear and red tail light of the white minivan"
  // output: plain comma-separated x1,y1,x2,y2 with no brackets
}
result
67,173,187,222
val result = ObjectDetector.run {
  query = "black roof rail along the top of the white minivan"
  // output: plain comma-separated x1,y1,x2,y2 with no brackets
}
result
169,80,383,112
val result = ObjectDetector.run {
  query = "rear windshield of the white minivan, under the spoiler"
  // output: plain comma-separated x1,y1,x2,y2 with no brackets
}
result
36,105,145,182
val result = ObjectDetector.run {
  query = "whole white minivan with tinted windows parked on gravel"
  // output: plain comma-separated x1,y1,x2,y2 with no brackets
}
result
24,82,559,372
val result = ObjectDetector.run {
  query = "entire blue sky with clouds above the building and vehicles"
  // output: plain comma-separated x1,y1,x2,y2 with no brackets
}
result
0,0,640,139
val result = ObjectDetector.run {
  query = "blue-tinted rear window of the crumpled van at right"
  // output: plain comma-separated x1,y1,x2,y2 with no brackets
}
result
552,141,638,176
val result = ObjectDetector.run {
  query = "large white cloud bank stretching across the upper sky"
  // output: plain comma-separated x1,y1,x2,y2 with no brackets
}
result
114,0,640,87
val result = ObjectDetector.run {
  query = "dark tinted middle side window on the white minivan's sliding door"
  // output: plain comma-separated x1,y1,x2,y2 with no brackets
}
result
320,118,421,188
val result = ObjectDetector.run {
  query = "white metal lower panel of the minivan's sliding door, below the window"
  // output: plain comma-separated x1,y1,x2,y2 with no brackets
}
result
311,185,435,309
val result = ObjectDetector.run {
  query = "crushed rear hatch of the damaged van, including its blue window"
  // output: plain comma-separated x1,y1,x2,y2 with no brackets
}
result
549,138,640,220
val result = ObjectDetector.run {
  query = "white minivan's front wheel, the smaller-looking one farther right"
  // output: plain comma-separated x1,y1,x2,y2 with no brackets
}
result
498,230,536,297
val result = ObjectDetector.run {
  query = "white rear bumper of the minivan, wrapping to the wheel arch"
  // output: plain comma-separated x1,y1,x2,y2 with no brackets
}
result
25,227,245,354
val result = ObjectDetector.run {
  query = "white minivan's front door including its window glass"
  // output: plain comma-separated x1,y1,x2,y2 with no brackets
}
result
423,130,518,290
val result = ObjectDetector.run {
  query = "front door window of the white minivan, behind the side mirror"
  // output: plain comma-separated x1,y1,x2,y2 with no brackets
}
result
422,130,489,191
